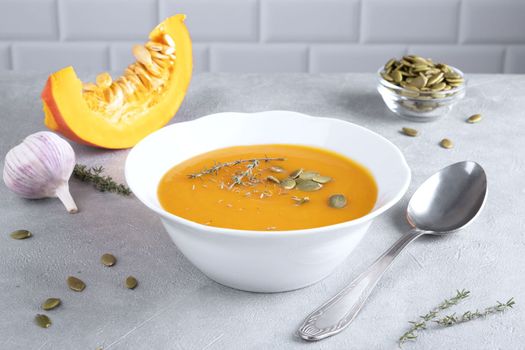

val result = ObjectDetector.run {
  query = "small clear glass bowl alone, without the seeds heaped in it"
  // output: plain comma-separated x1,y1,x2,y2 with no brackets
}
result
377,66,467,122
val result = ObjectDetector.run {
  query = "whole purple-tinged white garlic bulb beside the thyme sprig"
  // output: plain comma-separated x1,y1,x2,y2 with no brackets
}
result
4,131,78,213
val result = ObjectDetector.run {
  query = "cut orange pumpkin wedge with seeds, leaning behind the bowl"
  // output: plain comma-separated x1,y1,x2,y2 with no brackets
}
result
42,15,193,149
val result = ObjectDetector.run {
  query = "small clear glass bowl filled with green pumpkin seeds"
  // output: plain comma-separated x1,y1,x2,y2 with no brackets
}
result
377,55,466,122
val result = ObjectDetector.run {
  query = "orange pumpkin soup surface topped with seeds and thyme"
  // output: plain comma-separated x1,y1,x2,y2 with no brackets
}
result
158,144,377,231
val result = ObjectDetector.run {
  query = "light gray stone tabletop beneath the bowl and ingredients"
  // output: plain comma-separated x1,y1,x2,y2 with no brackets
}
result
0,73,525,350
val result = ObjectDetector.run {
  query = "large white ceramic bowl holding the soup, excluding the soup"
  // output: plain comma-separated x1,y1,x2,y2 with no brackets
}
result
126,111,410,292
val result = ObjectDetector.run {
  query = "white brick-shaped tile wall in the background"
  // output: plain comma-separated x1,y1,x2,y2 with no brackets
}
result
0,0,525,73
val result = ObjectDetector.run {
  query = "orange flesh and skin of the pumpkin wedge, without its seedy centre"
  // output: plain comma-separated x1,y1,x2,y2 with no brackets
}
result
42,15,193,149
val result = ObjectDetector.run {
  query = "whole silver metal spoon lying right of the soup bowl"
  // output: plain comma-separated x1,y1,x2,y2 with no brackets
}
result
299,161,487,341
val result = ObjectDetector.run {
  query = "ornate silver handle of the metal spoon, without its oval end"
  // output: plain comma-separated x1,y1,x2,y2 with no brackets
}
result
298,230,425,341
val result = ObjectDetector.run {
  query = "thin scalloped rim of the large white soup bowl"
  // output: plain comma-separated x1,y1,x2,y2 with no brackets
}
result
124,110,412,237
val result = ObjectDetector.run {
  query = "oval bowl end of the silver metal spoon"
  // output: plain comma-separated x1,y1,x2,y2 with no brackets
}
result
407,161,487,234
